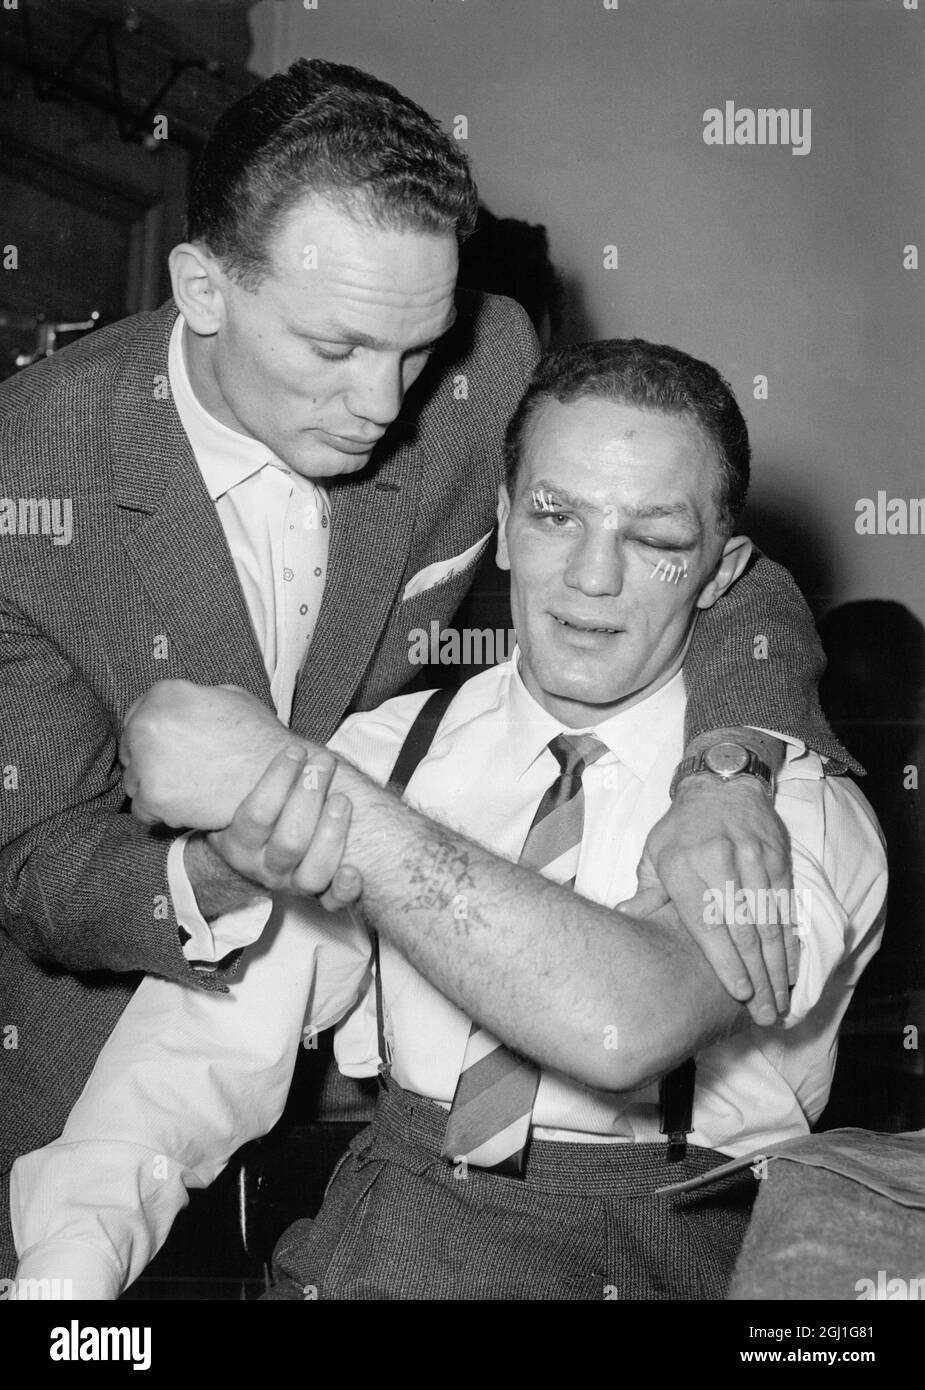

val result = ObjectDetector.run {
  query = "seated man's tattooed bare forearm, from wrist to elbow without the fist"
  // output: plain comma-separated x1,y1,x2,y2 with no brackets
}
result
321,762,739,1090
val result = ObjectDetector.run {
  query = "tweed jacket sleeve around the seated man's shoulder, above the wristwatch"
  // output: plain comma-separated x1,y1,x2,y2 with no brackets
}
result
684,555,864,773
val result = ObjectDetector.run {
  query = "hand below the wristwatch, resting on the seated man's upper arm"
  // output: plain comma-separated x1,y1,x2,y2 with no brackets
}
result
631,774,800,1024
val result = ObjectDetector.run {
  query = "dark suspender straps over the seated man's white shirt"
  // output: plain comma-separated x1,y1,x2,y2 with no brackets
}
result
373,691,697,1163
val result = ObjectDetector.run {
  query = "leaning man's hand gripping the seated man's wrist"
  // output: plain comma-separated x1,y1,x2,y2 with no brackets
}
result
204,745,363,910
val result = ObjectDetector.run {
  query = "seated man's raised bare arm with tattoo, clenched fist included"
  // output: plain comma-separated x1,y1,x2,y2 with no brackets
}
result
122,681,744,1091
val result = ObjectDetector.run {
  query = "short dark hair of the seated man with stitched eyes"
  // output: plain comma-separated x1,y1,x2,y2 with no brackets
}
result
505,338,751,535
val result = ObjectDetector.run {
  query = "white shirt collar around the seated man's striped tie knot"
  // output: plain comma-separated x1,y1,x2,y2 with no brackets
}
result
508,648,687,781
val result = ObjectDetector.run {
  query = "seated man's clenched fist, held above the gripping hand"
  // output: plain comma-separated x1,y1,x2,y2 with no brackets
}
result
118,681,314,830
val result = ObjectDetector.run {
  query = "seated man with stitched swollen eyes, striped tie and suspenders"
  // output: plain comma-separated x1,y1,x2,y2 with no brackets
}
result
13,341,886,1298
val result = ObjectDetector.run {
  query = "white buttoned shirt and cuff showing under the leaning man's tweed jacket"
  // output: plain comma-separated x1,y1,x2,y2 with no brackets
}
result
167,316,331,963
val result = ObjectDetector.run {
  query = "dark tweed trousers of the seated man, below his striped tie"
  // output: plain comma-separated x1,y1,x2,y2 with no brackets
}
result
264,1080,754,1301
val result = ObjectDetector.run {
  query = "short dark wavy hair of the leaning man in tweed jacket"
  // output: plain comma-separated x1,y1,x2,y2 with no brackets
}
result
186,58,478,289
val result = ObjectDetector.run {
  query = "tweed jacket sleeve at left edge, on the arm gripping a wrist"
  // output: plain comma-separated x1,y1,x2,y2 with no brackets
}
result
0,600,236,988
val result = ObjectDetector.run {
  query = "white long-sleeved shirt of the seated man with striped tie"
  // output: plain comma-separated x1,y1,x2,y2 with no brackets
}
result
11,653,886,1297
